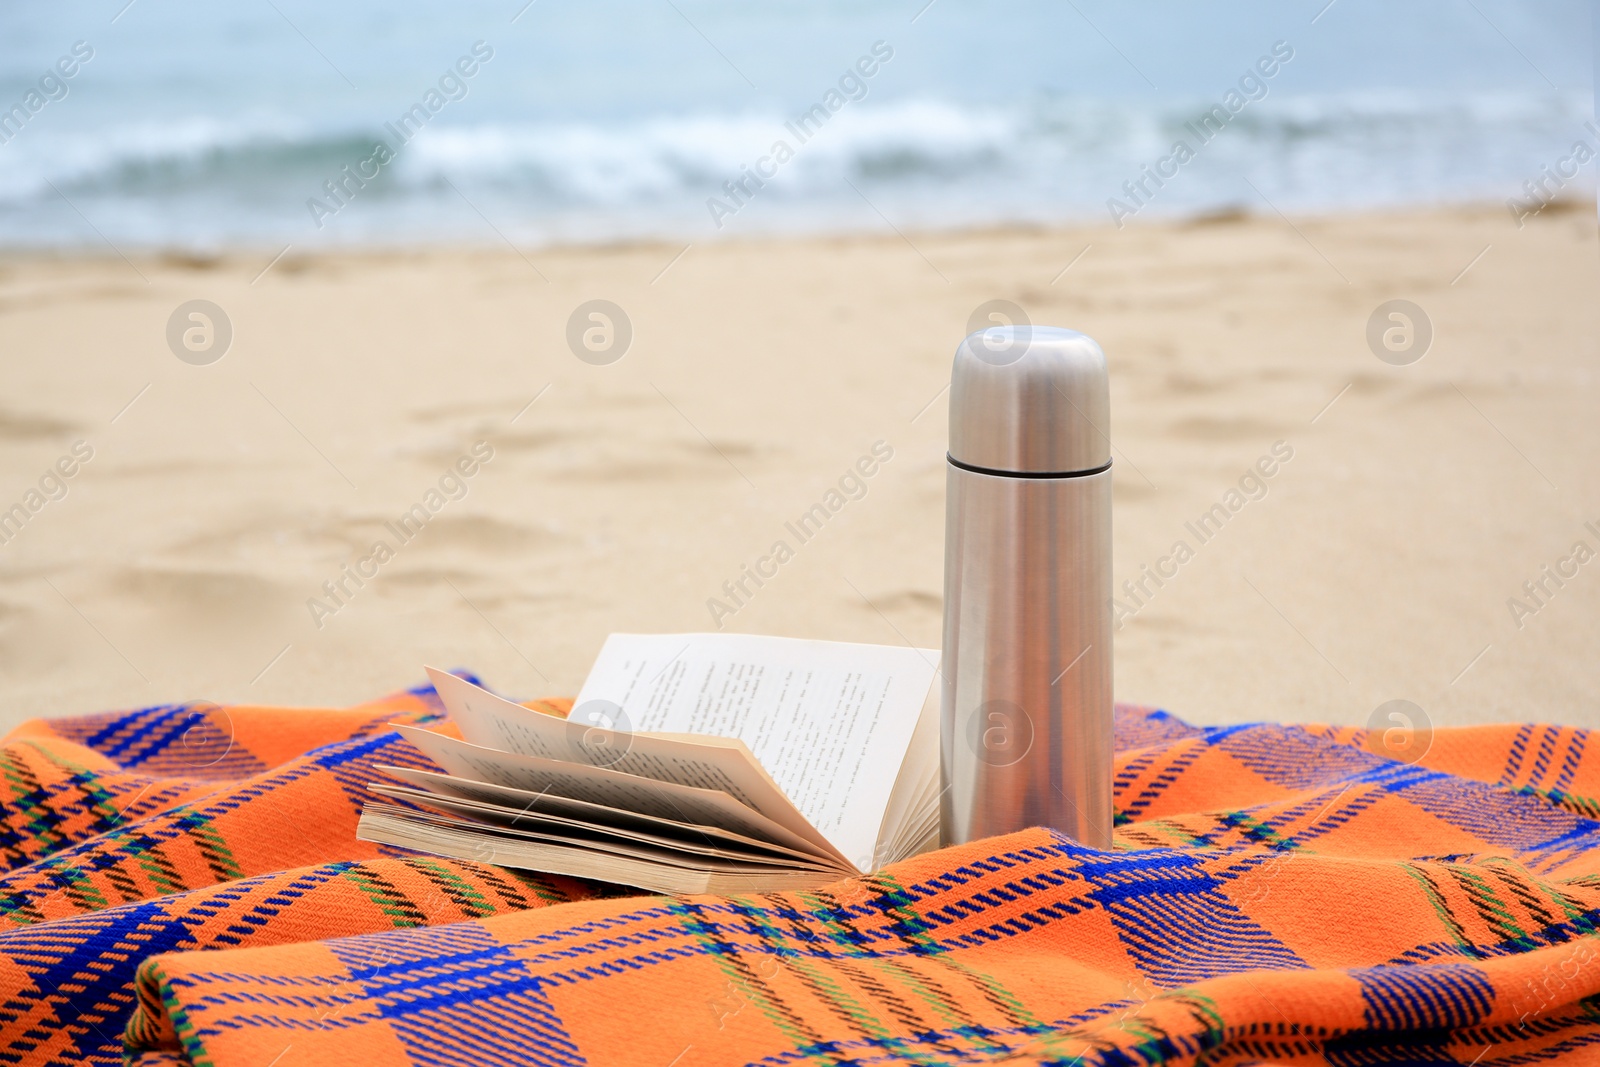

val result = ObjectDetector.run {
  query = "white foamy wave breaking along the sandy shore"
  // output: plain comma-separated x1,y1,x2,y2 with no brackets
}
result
0,93,1589,245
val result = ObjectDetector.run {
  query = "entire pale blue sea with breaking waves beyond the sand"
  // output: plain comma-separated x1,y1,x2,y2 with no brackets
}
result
0,0,1600,251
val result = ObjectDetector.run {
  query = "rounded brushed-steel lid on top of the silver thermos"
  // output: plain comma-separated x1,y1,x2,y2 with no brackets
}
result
950,326,1110,475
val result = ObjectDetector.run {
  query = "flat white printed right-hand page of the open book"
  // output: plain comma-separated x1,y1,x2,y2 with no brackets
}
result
573,633,939,859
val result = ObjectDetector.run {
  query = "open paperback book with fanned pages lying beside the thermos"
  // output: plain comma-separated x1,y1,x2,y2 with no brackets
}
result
357,633,939,894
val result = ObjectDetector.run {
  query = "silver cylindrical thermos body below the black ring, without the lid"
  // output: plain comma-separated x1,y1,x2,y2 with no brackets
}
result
942,464,1112,848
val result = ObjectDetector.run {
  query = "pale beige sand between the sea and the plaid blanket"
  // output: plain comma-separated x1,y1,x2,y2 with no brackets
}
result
0,206,1600,735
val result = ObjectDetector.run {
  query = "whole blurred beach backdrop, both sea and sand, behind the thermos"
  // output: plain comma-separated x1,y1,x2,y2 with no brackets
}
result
0,0,1600,735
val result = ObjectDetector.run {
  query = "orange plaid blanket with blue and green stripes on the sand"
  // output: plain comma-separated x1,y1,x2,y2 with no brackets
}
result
0,688,1600,1067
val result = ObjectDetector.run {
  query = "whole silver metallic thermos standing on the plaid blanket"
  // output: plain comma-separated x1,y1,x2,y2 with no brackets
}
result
939,325,1112,848
